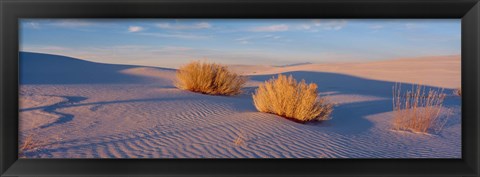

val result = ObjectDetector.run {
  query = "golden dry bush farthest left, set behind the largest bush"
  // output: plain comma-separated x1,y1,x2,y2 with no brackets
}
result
175,61,247,95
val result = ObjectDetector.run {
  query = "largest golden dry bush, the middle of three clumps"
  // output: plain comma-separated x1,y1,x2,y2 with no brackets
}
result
253,74,333,122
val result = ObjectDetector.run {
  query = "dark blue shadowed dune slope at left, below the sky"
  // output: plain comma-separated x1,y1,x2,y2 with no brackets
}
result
19,52,173,85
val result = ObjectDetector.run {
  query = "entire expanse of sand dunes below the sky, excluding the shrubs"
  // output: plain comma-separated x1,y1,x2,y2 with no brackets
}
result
20,52,461,158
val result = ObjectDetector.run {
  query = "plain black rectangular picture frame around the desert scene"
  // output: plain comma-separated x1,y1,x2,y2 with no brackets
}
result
0,0,480,176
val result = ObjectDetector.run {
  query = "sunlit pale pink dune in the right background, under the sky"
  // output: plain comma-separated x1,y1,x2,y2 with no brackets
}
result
231,55,461,89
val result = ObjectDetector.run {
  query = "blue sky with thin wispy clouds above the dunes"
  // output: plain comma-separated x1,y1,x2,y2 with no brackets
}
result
20,19,461,68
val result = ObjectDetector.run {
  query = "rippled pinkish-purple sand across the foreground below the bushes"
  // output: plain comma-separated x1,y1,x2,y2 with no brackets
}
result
21,81,461,158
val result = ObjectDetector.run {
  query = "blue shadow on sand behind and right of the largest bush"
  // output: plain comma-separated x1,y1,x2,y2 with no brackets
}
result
246,71,460,133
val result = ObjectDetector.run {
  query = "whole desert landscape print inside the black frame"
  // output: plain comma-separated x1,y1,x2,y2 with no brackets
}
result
18,19,462,159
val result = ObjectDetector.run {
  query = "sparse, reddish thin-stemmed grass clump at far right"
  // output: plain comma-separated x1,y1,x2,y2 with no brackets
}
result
393,84,448,133
